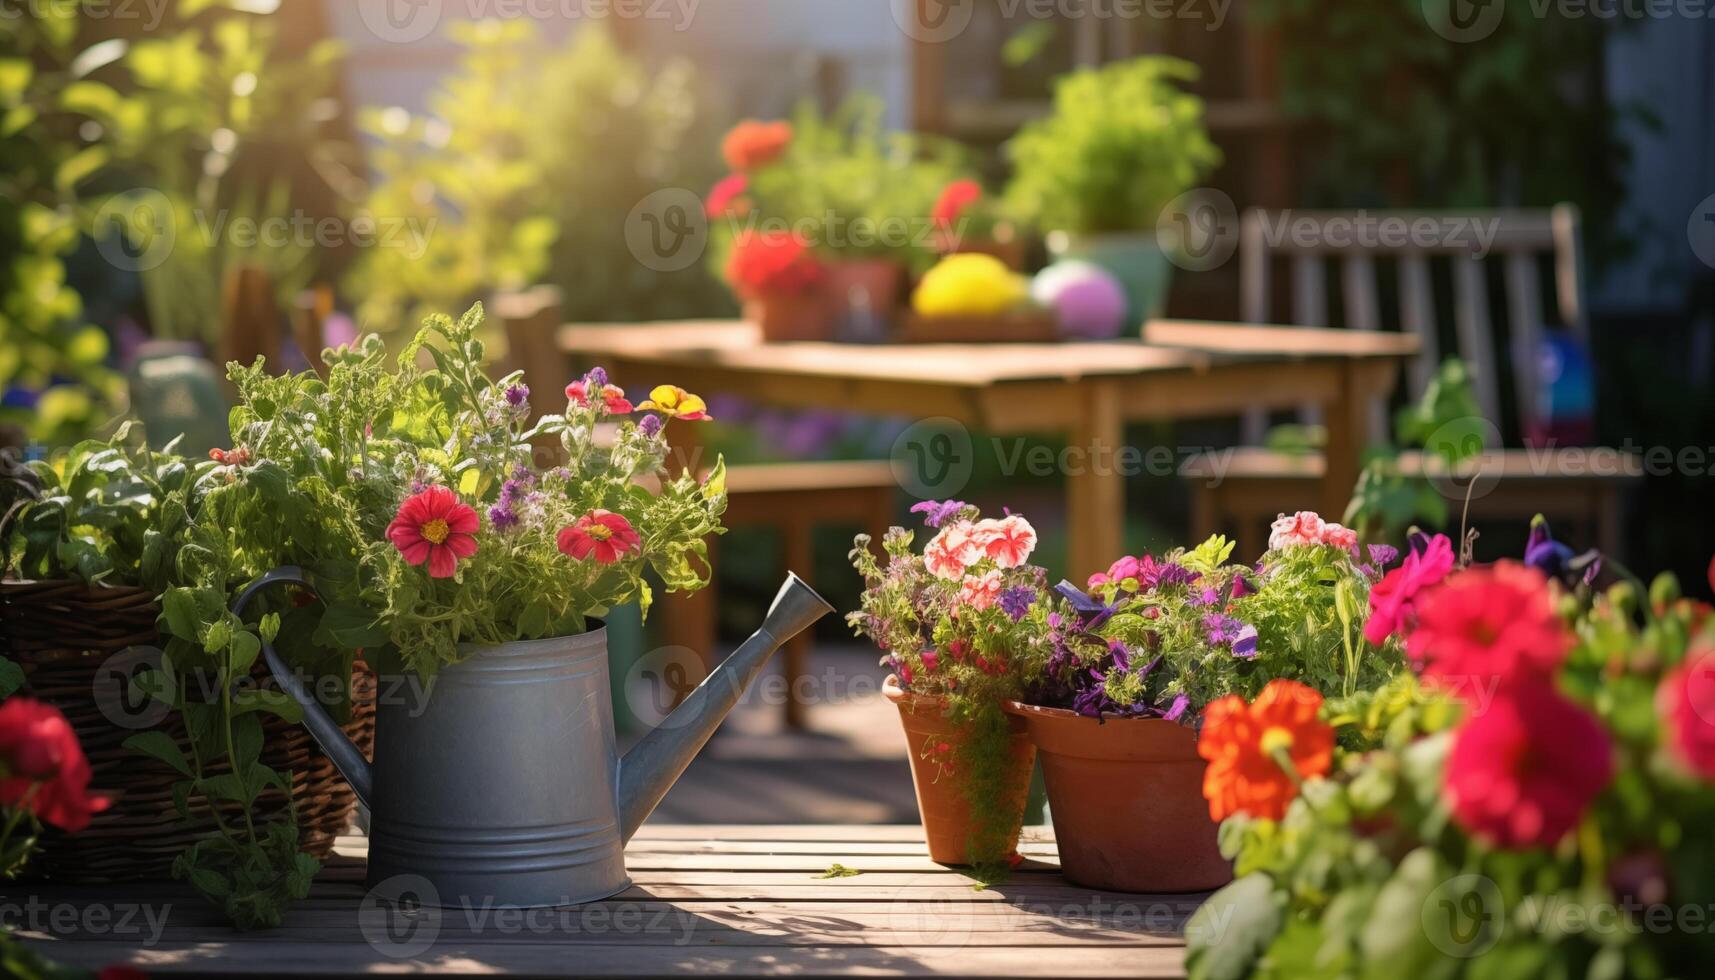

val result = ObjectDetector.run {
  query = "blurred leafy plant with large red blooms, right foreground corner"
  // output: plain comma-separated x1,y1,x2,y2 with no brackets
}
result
1187,525,1715,978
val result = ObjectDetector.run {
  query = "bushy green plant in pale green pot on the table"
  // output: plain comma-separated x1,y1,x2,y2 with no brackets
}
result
1007,57,1221,323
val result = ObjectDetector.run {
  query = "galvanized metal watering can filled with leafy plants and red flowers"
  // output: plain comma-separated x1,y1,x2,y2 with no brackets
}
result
119,305,825,925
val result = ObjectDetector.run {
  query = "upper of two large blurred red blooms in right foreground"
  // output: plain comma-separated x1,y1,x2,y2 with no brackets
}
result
1408,561,1573,687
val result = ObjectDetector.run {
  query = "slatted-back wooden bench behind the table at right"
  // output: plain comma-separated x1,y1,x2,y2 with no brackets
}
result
1182,204,1643,553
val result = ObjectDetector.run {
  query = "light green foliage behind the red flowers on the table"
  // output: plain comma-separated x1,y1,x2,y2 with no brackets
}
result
737,96,969,271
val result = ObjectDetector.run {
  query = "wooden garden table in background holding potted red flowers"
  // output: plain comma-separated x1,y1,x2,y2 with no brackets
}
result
557,321,1418,578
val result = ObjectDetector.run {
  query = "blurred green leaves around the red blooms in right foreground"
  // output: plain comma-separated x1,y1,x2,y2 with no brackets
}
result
1187,580,1715,978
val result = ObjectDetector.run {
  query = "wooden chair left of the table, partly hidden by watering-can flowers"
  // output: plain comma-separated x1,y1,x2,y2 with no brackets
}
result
490,287,897,728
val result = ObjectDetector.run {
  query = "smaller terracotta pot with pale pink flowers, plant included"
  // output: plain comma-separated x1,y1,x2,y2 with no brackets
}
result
847,501,1048,868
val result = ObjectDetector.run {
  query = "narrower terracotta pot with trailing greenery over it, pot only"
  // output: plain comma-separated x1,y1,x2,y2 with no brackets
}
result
882,678,1036,865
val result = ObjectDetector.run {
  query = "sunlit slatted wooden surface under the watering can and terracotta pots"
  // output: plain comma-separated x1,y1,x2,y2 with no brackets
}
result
20,824,1206,978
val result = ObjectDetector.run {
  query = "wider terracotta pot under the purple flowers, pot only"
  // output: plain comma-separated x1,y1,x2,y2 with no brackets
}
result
1007,702,1233,892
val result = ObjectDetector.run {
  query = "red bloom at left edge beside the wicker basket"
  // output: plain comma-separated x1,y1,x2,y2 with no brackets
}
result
0,697,110,832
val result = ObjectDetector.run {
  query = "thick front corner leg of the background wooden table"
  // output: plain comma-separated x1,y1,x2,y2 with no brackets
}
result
1067,384,1125,582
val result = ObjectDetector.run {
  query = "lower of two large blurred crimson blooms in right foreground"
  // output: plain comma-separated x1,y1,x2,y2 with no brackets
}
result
1442,678,1614,850
